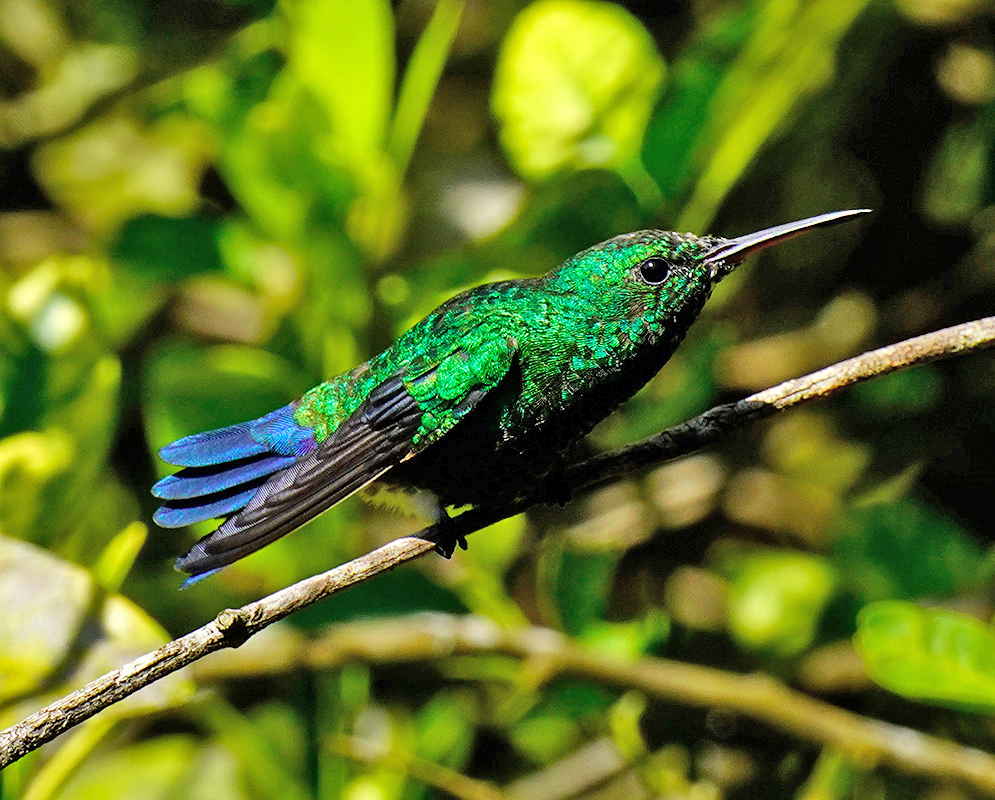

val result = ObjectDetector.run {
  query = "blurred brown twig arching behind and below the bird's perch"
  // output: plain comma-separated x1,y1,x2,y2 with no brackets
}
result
197,613,995,795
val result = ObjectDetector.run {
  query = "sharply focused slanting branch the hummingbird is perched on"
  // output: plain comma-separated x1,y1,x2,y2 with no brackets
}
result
0,317,995,769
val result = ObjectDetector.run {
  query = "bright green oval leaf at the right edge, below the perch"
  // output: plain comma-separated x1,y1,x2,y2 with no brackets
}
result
854,601,995,713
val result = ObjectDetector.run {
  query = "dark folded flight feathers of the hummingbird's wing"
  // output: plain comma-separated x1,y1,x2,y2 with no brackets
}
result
176,377,422,577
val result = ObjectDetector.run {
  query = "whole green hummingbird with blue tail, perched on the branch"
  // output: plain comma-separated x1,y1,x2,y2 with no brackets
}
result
152,209,868,583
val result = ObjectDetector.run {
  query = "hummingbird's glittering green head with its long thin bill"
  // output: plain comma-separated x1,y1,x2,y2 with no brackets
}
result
548,209,868,346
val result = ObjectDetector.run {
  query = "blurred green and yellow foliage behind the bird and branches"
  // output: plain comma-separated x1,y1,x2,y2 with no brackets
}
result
0,0,995,800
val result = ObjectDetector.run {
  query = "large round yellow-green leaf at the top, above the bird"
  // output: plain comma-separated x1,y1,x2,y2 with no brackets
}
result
491,0,665,181
